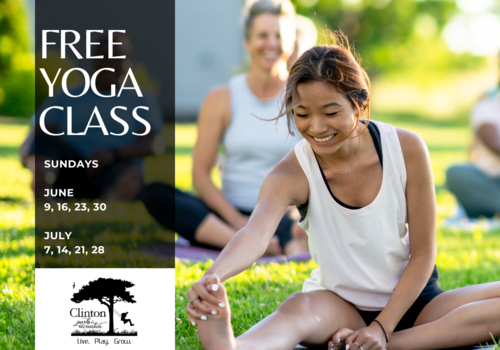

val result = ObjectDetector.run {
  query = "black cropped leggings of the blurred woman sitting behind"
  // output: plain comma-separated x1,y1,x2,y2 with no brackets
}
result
142,182,294,249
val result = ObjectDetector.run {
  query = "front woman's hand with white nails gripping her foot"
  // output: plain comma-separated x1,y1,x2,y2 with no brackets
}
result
186,274,226,326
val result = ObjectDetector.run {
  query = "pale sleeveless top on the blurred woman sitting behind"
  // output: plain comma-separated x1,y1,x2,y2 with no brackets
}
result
220,74,302,211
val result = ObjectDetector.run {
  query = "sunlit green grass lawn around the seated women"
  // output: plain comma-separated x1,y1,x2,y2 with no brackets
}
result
0,118,500,350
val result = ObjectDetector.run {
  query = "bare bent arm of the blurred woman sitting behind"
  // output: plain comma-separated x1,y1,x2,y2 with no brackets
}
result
193,86,246,229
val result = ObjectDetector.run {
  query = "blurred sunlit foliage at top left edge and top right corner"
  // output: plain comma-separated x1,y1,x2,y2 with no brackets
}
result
0,0,500,119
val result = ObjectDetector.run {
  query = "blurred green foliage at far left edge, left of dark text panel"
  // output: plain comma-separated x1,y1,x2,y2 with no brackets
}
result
0,0,35,116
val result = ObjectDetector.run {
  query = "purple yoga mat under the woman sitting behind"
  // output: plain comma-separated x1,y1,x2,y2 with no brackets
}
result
175,245,311,264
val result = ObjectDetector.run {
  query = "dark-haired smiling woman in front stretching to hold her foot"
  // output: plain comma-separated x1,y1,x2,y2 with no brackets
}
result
187,33,500,350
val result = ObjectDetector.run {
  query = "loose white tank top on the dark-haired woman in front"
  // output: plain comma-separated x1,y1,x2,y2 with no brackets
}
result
295,121,410,311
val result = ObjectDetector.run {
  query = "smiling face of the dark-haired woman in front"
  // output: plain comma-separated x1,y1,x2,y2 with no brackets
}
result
293,81,357,156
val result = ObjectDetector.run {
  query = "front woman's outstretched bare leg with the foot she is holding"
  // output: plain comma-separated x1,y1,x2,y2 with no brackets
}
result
195,284,365,350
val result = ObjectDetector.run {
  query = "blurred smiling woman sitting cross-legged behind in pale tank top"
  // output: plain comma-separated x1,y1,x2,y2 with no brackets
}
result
143,0,307,255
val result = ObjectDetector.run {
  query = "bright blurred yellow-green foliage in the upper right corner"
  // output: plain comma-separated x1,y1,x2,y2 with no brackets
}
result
292,0,500,121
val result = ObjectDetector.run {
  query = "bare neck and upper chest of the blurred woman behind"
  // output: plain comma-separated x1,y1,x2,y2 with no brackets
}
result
247,61,288,99
